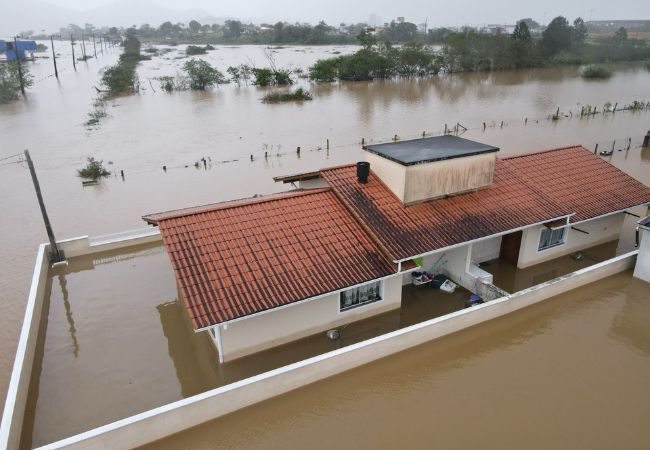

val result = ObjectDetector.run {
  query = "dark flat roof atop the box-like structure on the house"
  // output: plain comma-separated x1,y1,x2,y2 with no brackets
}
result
363,134,499,166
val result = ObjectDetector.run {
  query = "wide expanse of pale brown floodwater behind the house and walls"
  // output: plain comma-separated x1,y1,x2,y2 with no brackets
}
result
0,43,650,442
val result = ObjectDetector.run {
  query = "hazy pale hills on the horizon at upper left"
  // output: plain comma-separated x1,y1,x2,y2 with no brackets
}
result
0,0,225,36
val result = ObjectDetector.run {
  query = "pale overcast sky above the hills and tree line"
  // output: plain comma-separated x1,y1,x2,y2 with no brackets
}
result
38,0,650,26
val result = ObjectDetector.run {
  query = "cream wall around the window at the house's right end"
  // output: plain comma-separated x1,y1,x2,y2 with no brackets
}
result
517,213,625,269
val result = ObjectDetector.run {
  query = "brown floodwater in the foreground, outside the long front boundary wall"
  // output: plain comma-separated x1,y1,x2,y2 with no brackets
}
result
146,272,650,450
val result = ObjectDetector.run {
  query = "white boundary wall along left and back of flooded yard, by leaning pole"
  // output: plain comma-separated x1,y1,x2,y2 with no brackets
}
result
0,228,162,450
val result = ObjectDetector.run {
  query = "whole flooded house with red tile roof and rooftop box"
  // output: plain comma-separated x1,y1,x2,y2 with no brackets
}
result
144,136,650,361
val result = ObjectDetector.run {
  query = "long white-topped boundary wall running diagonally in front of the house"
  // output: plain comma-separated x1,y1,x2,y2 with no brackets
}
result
13,251,638,450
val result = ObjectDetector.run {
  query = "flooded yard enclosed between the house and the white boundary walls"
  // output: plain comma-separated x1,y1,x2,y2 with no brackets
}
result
23,244,470,448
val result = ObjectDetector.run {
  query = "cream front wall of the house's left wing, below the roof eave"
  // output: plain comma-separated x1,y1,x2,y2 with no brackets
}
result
215,274,402,361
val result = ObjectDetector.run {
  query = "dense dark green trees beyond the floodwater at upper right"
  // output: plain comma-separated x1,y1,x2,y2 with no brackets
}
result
309,16,650,82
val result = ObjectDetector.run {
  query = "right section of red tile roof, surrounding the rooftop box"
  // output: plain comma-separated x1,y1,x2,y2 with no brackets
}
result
321,146,650,260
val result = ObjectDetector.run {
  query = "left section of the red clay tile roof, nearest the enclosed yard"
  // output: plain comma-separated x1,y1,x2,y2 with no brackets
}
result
145,189,395,329
